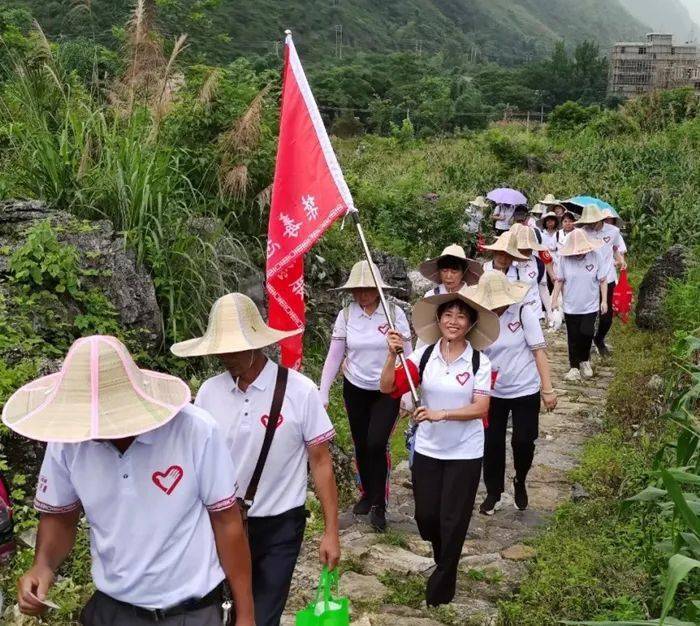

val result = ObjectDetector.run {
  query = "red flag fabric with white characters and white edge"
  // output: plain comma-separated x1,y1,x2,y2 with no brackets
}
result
266,34,354,369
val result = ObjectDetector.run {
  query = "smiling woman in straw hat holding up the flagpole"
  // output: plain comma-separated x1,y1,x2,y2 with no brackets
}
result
381,287,498,606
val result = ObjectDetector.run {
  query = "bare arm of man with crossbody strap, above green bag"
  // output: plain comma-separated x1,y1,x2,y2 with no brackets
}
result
308,443,340,570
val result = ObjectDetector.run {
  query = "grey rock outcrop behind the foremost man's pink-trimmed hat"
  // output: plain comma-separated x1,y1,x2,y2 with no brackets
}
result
0,200,163,348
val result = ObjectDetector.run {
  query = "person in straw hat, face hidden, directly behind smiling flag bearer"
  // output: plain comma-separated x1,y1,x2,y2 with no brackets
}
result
468,271,557,515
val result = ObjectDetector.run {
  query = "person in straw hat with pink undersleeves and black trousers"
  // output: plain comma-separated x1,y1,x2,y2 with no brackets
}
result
319,260,413,532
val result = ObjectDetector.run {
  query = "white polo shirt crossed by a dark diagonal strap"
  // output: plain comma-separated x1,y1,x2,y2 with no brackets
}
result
195,360,335,517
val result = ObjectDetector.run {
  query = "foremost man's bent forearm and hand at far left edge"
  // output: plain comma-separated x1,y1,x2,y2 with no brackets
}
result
17,506,81,615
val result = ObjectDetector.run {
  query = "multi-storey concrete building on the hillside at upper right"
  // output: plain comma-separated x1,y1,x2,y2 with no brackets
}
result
608,33,700,97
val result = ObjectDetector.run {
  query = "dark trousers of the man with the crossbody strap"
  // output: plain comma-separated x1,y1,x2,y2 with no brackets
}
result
248,506,306,626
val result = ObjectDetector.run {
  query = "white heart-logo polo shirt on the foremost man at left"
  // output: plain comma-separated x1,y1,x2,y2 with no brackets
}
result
34,405,237,608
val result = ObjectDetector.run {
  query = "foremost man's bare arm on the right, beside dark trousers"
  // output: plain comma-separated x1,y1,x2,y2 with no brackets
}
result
209,504,255,626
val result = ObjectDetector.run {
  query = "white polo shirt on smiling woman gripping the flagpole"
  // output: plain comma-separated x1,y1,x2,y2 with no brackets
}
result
408,344,491,460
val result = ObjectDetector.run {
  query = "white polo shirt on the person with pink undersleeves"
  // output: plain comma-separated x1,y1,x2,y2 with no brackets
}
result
332,302,411,390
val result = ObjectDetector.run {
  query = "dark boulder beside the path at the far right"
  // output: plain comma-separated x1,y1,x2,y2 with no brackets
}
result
636,245,691,330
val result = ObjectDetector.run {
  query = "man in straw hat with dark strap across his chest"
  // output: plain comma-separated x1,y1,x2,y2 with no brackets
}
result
171,293,340,626
